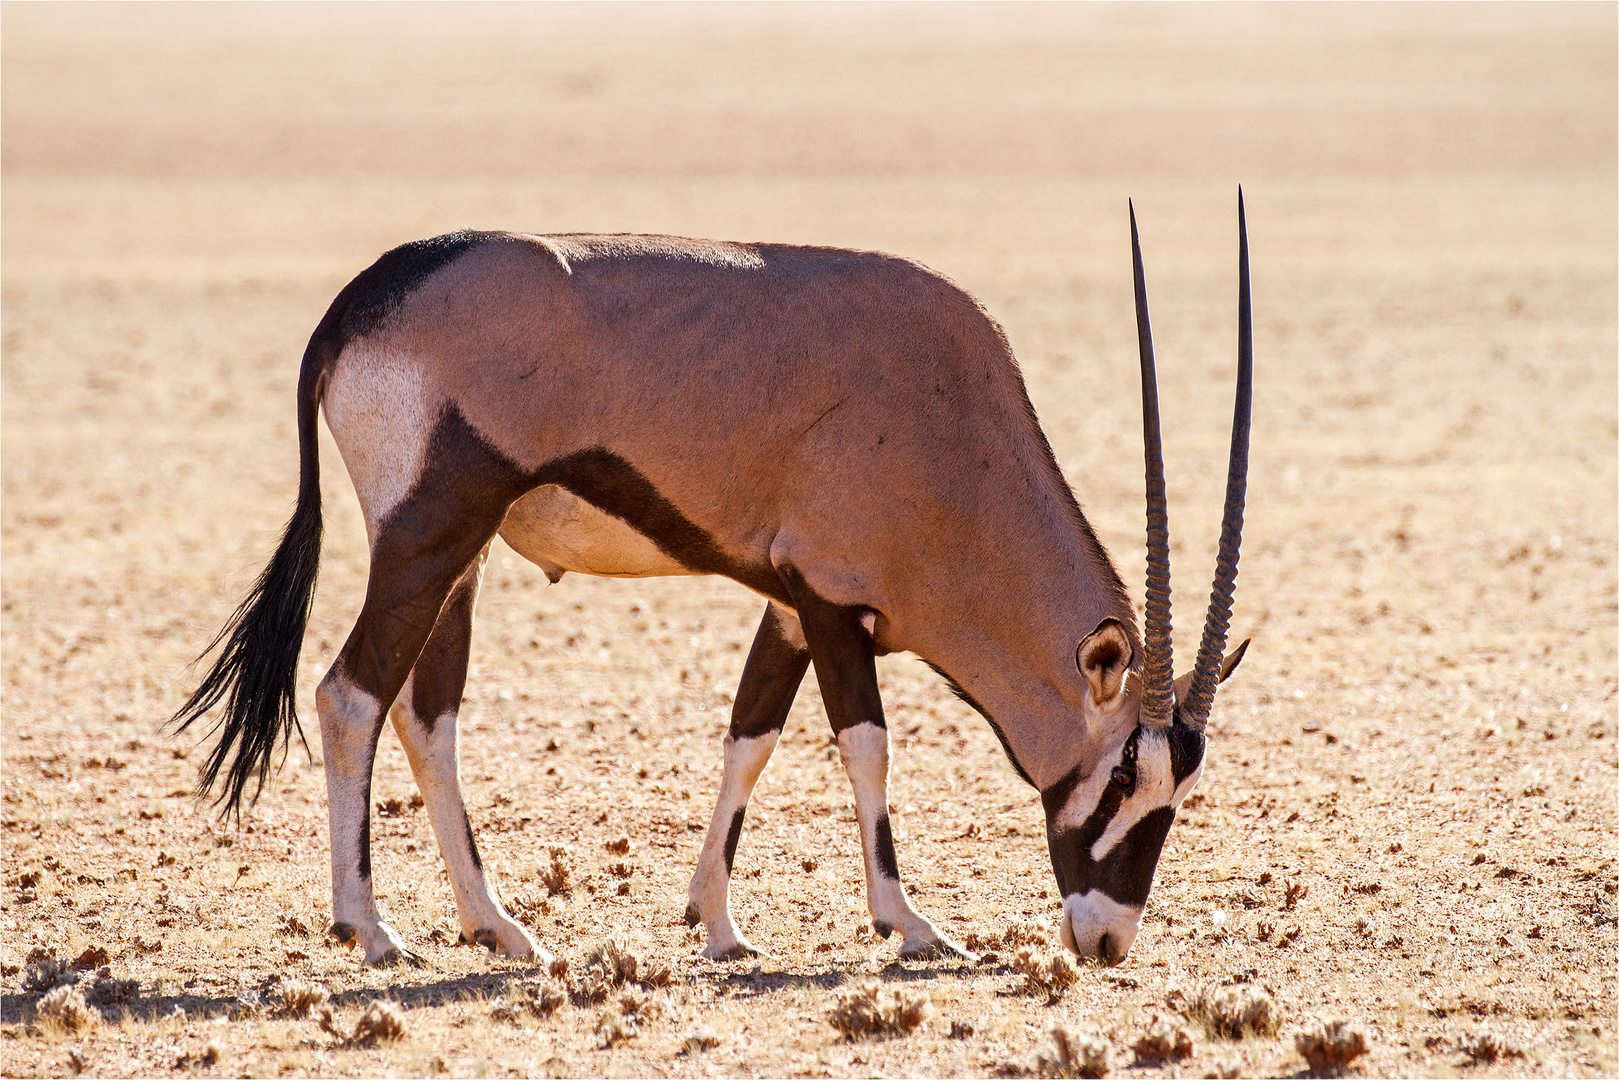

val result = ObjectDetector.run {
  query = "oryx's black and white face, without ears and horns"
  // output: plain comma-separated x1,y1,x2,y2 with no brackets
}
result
1041,719,1205,963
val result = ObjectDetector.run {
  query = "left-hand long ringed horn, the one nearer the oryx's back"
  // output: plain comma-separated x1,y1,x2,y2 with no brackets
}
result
1130,202,1175,729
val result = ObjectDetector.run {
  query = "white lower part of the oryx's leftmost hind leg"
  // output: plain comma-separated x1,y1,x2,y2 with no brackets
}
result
316,665,411,963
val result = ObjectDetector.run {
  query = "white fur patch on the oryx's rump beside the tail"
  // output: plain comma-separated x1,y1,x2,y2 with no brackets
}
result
322,340,437,541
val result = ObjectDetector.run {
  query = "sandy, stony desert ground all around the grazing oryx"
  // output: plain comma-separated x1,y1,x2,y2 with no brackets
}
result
0,3,1619,1077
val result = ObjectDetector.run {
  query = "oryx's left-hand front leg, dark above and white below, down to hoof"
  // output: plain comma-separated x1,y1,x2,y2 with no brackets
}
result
686,602,810,960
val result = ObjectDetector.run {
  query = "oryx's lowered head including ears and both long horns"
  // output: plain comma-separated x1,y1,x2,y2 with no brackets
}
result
1041,189,1253,963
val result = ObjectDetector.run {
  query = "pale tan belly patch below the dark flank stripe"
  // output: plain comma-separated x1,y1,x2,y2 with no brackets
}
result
500,484,695,581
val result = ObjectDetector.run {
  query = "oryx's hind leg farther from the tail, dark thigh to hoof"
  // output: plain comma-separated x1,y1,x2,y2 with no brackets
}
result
389,544,550,963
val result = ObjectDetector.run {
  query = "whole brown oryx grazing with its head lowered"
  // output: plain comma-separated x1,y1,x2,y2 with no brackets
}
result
175,193,1253,963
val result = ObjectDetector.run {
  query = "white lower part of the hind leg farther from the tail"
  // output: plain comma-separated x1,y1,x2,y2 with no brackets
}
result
390,677,550,963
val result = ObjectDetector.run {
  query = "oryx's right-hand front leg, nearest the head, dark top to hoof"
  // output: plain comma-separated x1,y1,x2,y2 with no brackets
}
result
780,567,973,959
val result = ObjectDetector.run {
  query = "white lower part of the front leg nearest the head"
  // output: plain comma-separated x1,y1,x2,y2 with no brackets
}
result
837,724,968,955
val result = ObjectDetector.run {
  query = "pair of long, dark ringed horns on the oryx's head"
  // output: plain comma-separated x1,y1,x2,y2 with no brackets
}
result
1130,188,1253,732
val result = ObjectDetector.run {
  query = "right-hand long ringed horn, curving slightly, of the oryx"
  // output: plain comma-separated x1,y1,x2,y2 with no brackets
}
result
1180,188,1253,730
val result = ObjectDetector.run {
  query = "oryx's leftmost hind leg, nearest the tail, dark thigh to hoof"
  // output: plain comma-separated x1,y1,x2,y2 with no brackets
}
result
316,470,510,963
